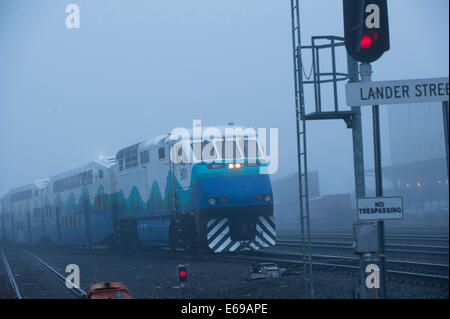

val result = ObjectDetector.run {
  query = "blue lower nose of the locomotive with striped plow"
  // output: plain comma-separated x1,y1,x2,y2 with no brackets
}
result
190,174,276,252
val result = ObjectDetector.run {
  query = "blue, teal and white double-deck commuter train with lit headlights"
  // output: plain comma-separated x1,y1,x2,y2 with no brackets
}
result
0,125,276,253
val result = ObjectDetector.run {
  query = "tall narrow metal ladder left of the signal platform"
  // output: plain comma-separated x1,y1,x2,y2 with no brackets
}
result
291,0,314,299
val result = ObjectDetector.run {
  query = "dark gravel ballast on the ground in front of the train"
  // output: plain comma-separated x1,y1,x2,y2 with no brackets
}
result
8,250,448,299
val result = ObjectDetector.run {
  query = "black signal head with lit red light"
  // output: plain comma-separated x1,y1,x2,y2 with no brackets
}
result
343,0,389,63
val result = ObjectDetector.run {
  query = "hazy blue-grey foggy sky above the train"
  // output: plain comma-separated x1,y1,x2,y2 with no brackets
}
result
0,0,449,193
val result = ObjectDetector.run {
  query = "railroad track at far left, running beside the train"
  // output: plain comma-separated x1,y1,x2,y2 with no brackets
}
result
0,249,86,299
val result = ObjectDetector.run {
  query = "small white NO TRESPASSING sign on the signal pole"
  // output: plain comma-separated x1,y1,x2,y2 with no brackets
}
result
357,197,403,220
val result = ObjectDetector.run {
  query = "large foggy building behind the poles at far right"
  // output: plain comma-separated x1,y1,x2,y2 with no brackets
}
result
383,103,448,225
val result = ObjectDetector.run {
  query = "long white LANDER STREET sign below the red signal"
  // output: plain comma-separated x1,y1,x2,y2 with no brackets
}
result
345,77,449,106
